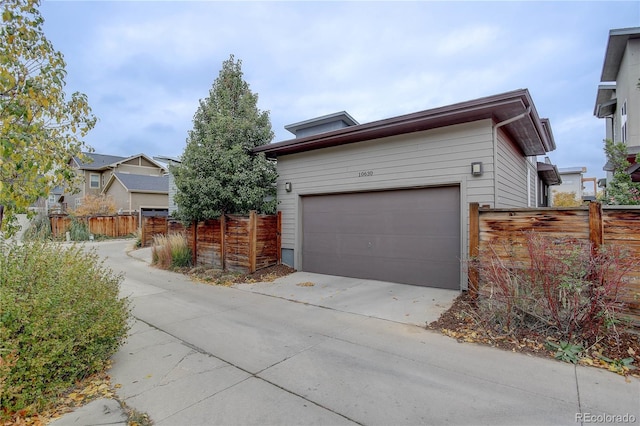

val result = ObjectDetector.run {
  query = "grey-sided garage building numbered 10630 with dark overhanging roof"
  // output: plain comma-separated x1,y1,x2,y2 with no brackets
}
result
254,89,560,289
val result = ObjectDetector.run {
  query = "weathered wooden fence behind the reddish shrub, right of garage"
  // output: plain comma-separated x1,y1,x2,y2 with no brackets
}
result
469,202,640,326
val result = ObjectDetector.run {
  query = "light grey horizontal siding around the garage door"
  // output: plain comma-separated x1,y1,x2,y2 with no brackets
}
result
278,120,500,286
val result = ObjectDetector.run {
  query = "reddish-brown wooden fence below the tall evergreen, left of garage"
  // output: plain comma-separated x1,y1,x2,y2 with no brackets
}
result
142,212,281,273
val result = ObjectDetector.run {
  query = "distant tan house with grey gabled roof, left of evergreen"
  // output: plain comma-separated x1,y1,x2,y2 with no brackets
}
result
62,153,169,214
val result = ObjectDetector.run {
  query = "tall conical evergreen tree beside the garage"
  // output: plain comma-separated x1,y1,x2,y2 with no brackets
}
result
171,55,277,222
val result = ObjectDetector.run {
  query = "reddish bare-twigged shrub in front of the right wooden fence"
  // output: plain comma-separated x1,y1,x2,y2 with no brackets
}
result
477,233,637,341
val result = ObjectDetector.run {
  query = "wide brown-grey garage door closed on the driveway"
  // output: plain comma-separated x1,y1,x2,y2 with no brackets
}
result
302,187,460,289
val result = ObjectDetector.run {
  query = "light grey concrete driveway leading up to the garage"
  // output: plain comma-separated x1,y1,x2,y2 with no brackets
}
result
52,242,640,425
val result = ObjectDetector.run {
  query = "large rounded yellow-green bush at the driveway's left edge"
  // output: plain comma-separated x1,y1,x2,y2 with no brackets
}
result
0,241,129,417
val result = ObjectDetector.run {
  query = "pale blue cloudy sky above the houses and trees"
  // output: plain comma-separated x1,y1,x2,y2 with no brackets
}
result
40,0,640,177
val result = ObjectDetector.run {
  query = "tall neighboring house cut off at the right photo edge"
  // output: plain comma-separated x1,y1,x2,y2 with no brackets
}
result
594,27,640,182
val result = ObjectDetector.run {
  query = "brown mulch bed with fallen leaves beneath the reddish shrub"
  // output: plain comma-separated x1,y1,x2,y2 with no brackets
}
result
427,293,640,377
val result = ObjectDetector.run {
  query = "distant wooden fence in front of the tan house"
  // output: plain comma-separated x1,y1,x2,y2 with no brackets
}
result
49,215,138,238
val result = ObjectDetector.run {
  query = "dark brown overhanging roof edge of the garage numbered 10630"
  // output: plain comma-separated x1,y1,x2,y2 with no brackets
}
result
253,89,556,158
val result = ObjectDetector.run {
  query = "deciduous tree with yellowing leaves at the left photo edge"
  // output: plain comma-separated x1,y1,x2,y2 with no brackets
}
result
0,0,96,235
